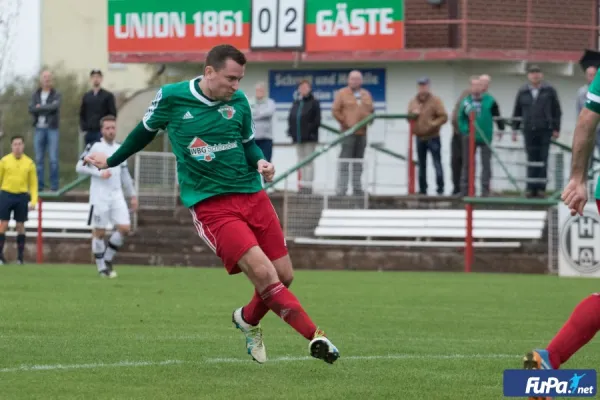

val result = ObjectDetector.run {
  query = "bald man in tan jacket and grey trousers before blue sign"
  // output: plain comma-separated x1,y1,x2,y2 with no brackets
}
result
331,70,374,196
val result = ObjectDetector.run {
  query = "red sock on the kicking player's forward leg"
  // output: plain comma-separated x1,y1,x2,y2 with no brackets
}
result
261,282,317,340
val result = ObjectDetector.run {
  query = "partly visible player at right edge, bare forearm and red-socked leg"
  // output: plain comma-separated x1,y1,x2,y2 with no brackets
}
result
524,65,600,378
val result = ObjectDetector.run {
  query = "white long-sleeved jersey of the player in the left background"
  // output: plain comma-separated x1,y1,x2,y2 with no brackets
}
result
76,139,135,206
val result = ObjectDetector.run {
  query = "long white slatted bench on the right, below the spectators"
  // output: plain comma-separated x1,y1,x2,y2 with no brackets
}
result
294,209,547,248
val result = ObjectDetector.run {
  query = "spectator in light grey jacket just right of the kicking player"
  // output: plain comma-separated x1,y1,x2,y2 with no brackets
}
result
252,82,275,162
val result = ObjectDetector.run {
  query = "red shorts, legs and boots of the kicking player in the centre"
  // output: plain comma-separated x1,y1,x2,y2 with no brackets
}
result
192,192,339,363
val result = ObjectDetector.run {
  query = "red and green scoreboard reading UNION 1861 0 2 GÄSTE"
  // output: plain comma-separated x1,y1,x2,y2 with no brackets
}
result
108,0,404,53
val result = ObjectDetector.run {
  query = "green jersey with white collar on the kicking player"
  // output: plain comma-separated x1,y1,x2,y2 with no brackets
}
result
142,76,262,207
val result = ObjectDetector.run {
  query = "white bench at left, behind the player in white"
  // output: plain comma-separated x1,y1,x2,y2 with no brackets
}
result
6,201,112,239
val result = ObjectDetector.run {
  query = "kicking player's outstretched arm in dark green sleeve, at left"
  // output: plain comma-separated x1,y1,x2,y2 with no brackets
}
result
106,88,169,168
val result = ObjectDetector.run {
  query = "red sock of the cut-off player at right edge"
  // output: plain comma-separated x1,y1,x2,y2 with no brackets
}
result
546,293,600,368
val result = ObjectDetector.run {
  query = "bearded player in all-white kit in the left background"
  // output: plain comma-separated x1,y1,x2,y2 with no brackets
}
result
76,115,138,278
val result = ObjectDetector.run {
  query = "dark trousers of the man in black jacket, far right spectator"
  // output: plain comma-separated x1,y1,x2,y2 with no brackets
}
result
524,131,552,196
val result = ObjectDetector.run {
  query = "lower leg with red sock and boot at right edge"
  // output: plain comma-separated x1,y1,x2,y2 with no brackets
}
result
524,293,600,369
